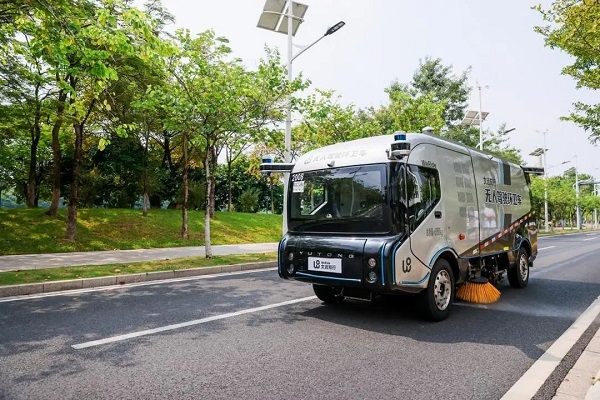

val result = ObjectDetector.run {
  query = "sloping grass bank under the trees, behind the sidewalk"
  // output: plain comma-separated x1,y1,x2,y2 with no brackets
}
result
0,208,281,255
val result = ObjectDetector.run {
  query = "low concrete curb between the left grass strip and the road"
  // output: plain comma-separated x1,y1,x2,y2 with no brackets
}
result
0,261,277,297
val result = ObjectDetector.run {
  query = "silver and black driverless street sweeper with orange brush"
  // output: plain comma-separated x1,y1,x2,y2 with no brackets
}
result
261,132,541,321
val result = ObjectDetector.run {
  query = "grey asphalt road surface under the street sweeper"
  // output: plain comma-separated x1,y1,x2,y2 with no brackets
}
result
0,233,600,399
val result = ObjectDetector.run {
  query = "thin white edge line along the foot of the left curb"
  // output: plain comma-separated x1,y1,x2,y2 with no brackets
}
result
0,267,277,303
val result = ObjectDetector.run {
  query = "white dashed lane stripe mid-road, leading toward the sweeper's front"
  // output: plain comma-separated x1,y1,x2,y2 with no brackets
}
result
71,296,317,350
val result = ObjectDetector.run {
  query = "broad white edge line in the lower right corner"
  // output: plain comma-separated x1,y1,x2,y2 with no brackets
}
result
500,296,600,400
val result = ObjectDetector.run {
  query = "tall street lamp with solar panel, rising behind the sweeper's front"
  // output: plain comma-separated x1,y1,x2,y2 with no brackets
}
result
257,0,346,235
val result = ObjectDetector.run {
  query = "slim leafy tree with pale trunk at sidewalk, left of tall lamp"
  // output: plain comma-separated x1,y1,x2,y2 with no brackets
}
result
157,30,303,258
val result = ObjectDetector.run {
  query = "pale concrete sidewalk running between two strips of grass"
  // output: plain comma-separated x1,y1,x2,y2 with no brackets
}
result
0,243,278,272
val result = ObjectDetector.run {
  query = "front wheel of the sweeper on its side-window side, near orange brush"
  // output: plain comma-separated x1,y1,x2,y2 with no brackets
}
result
420,259,455,321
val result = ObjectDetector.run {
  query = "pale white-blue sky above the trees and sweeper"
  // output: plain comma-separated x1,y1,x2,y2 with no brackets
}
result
157,0,600,180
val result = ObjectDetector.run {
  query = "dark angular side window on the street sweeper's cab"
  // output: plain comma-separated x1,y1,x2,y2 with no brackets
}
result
406,165,442,230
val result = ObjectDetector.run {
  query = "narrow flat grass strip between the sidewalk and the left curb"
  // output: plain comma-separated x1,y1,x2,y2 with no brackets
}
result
0,252,277,286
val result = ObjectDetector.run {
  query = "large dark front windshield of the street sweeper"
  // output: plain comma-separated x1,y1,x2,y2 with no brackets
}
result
288,164,392,233
